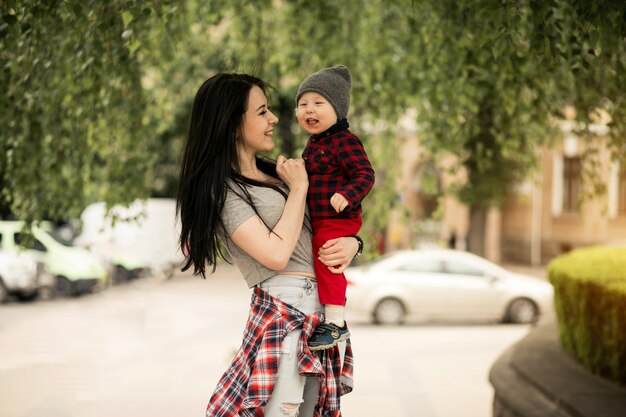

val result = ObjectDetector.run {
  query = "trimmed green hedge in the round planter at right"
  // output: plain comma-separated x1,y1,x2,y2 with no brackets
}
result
548,247,626,384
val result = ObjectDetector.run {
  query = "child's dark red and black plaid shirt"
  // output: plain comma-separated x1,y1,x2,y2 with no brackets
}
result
302,119,375,219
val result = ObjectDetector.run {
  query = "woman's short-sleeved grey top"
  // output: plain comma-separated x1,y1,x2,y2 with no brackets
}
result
220,183,315,288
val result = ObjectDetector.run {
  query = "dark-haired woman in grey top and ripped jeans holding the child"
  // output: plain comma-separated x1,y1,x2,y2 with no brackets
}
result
177,74,359,417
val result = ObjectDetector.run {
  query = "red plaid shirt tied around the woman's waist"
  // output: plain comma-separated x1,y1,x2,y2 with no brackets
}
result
206,287,352,417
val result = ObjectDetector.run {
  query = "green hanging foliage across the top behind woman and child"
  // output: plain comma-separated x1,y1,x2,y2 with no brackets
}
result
0,0,626,256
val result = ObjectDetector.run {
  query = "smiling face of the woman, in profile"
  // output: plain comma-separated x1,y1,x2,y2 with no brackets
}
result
241,85,278,154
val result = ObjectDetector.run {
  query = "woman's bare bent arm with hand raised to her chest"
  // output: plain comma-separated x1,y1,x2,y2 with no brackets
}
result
231,156,309,271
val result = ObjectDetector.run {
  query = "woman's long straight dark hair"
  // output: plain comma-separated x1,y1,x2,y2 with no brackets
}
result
176,73,286,277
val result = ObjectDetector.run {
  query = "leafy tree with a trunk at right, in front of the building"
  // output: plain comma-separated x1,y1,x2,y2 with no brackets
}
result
410,0,626,253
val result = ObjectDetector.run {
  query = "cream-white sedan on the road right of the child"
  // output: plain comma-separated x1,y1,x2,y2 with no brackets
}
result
345,249,553,324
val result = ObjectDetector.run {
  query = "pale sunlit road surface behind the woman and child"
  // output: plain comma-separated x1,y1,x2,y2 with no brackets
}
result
0,265,529,417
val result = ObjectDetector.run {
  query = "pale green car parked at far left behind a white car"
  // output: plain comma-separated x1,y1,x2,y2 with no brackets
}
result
0,221,107,296
